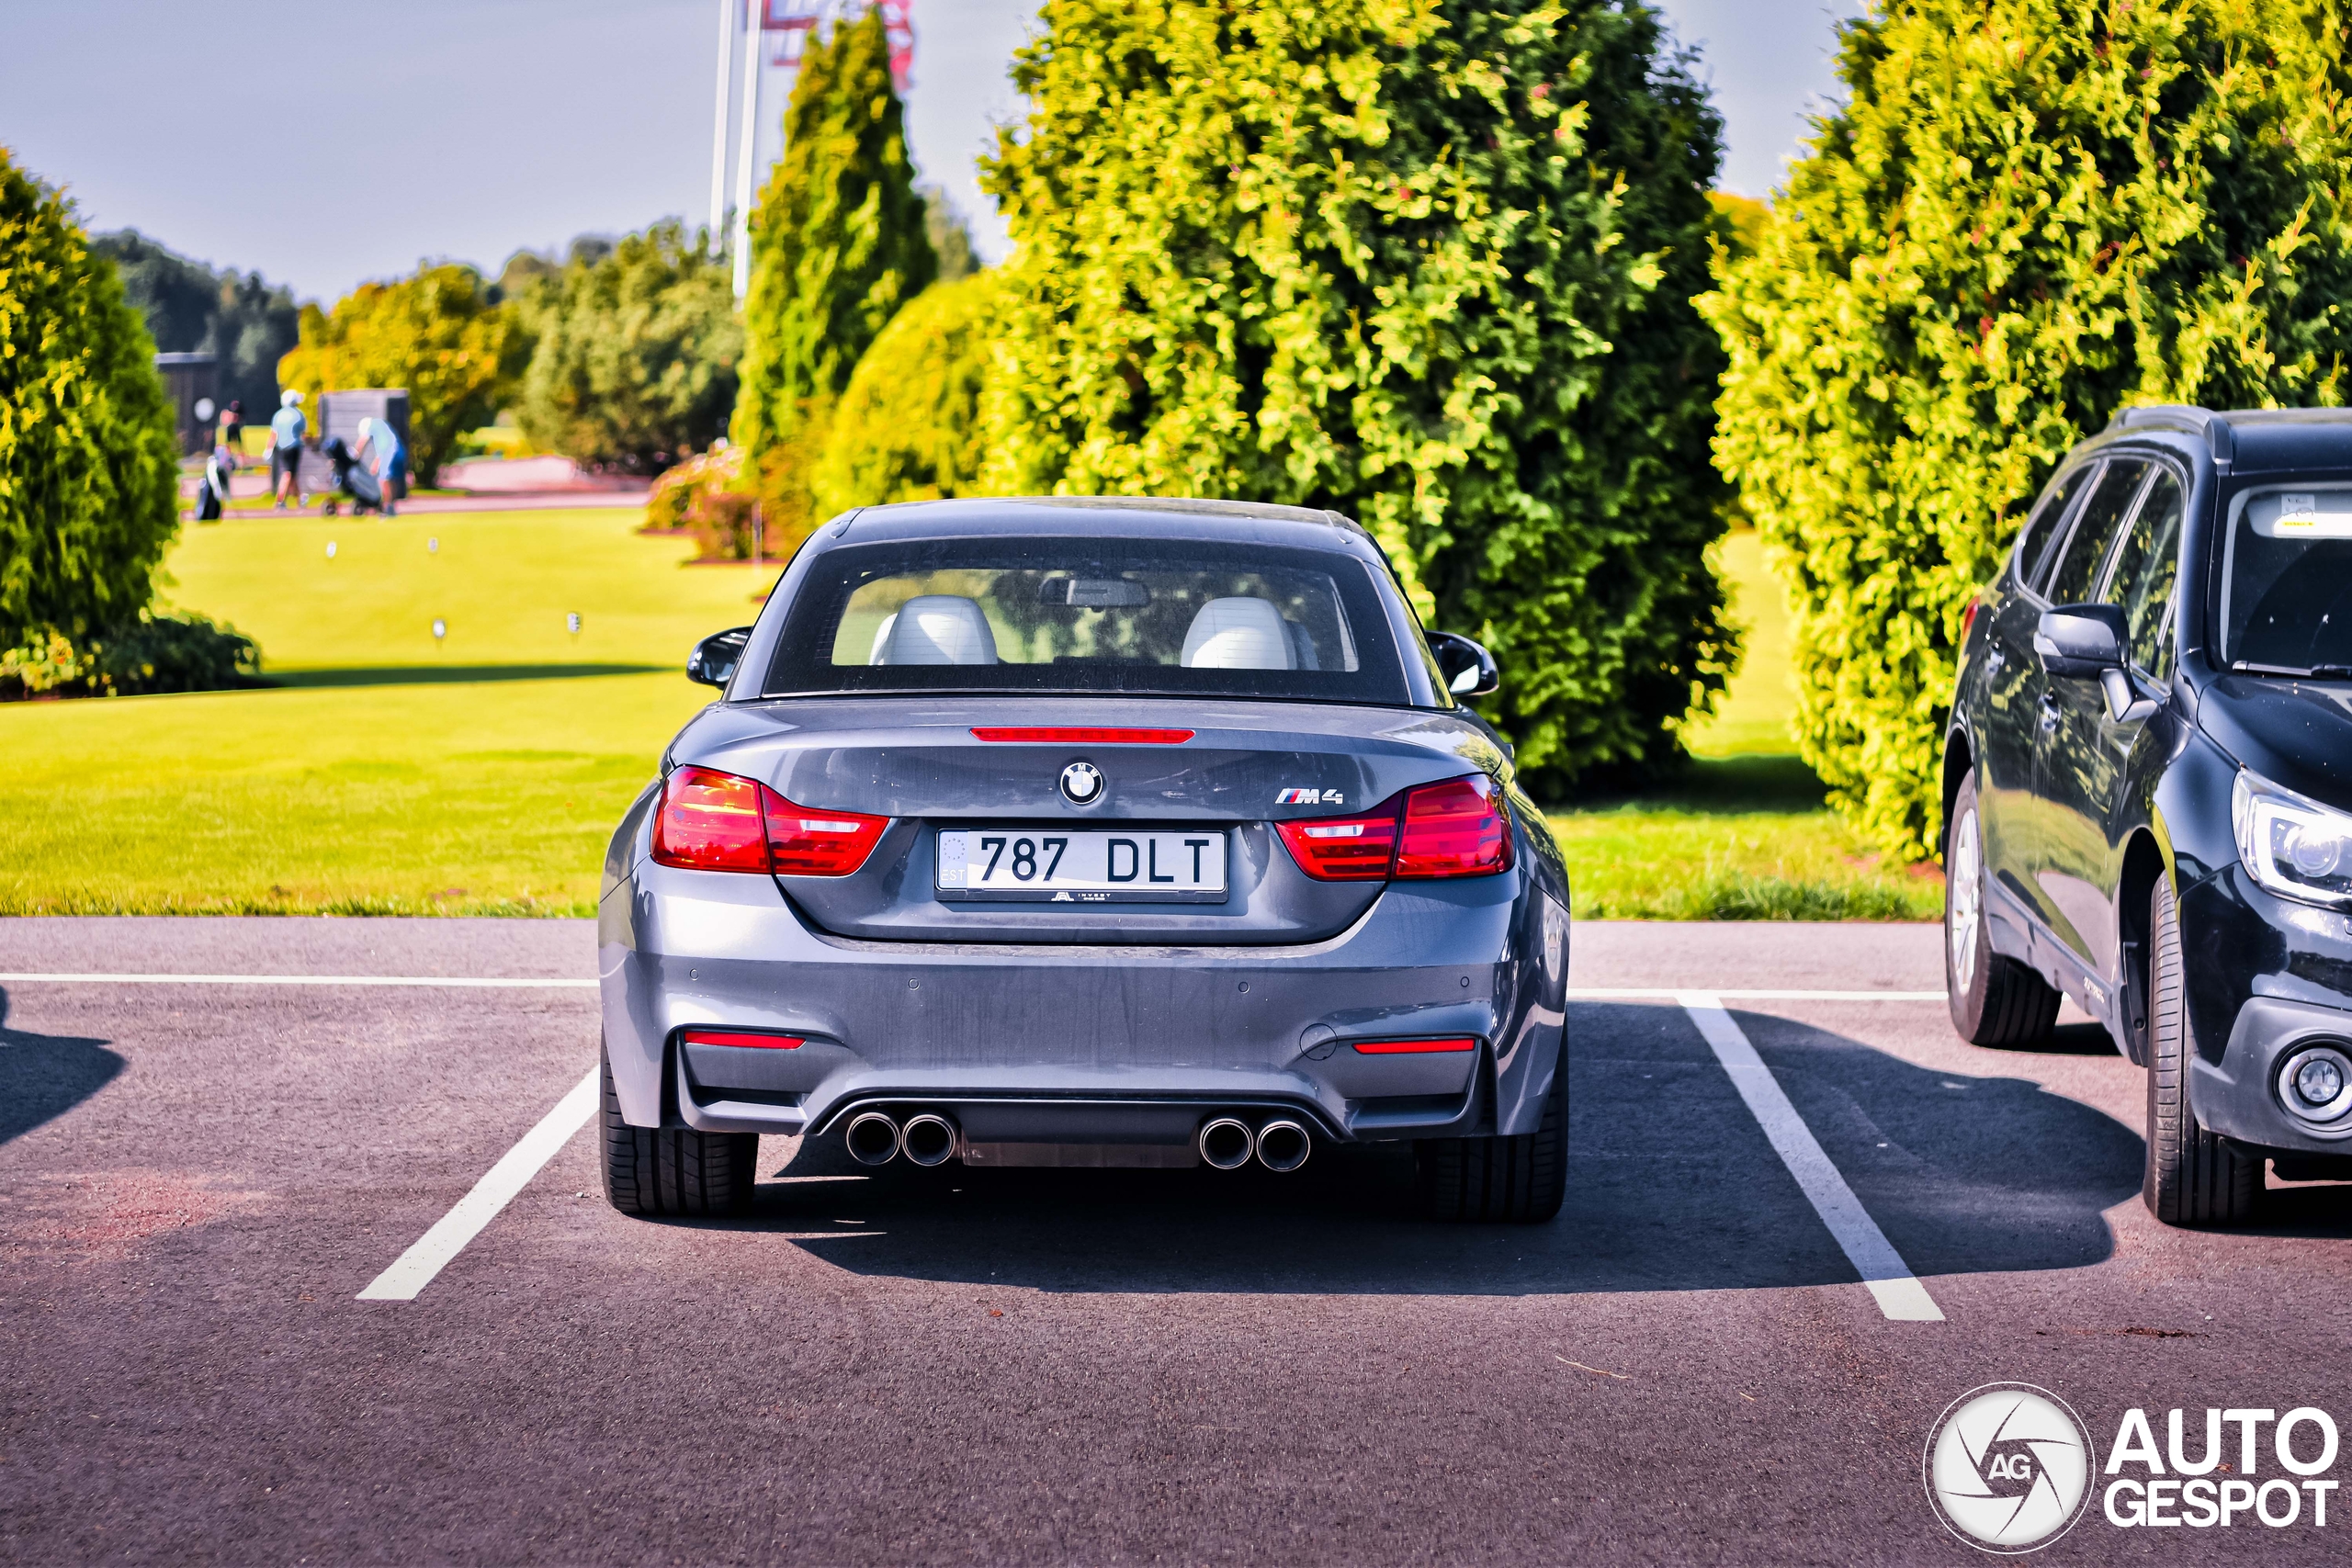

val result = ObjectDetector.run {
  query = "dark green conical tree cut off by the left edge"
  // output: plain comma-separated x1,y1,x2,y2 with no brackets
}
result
0,148,179,649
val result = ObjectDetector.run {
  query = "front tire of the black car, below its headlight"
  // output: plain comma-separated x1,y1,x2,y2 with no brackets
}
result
2141,877,2263,1227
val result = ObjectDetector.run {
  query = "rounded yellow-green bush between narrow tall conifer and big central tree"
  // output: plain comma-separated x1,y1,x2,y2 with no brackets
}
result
814,273,997,520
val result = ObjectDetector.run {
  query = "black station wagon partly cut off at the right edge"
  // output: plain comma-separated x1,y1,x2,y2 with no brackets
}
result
1943,407,2352,1224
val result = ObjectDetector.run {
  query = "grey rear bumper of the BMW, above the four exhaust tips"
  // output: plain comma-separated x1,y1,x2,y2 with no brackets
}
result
597,861,1566,1145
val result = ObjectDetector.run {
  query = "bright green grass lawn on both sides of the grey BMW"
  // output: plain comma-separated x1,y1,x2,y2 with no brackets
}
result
0,510,1940,919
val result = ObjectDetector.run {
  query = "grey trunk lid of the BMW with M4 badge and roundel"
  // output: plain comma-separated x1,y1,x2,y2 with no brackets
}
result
671,696,1508,945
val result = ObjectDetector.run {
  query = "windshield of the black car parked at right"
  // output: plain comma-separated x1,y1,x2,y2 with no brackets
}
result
2221,484,2352,674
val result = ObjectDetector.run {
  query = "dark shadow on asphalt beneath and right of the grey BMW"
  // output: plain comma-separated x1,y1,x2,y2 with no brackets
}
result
700,1004,2141,1295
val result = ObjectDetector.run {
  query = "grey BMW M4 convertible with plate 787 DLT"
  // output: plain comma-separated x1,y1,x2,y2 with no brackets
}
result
597,499,1569,1220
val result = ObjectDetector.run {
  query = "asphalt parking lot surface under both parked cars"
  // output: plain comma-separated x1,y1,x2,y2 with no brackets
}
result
0,919,2352,1563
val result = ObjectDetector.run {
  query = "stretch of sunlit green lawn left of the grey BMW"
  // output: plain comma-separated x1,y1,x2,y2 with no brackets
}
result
0,510,752,915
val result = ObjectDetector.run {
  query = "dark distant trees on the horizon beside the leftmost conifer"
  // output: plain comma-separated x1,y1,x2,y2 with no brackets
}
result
89,228,299,415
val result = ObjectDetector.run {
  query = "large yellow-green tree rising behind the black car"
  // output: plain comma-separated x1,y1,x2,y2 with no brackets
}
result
1702,0,2352,856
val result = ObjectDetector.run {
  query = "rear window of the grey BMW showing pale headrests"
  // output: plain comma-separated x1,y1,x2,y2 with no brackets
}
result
764,538,1408,703
